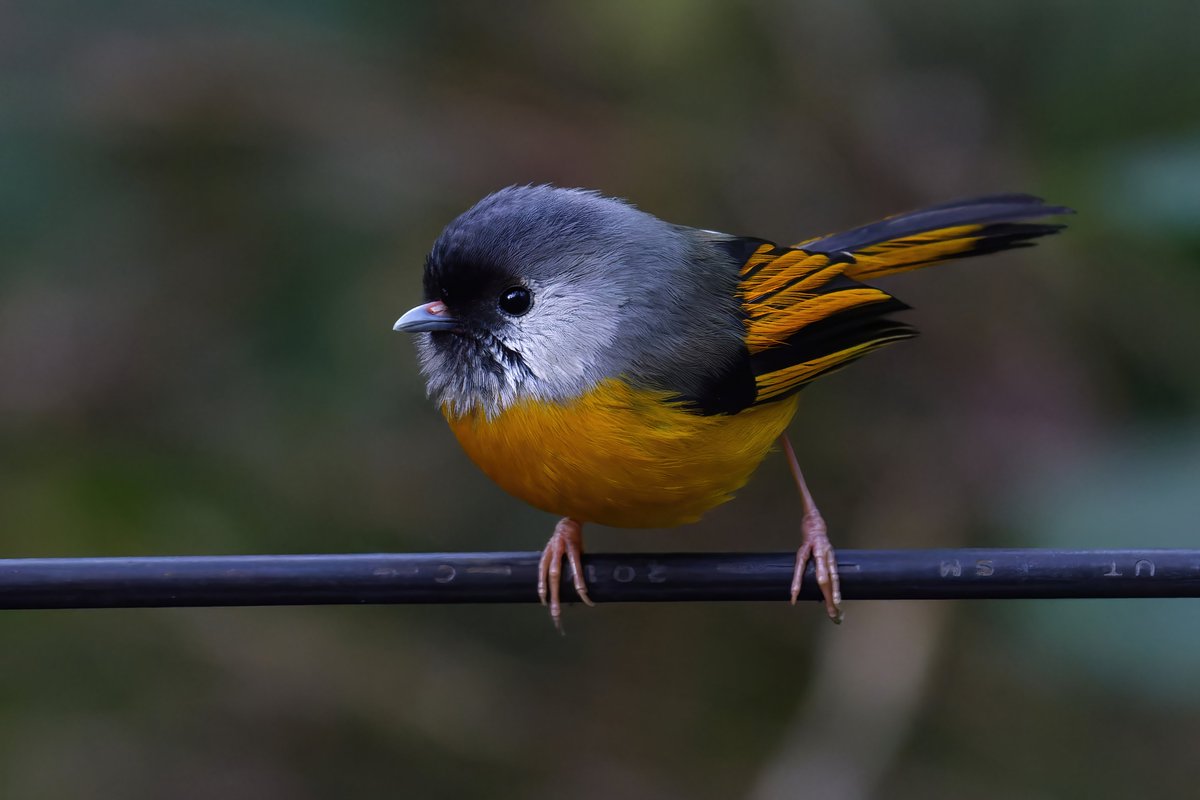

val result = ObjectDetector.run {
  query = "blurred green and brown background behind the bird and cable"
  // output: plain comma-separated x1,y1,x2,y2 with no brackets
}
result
0,0,1200,800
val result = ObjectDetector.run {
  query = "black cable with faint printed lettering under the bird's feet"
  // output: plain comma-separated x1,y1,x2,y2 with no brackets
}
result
0,548,1200,608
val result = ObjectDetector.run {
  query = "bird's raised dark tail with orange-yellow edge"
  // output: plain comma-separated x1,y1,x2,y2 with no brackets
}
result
794,194,1073,281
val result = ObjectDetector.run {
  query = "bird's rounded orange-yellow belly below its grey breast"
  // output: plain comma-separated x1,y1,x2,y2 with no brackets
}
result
443,379,797,528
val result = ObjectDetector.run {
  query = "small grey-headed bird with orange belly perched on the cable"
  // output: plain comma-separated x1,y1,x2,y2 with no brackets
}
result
394,184,1073,630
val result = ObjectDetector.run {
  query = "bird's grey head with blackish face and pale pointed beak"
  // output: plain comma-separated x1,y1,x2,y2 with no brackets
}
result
395,186,670,415
